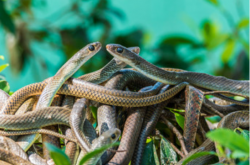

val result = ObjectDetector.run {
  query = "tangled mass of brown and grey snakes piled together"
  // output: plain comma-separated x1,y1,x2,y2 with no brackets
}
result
0,42,249,165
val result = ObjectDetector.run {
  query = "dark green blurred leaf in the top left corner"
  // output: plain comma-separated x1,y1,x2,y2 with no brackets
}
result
0,1,16,34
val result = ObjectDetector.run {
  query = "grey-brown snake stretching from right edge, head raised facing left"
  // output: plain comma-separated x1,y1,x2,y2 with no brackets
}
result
106,44,249,98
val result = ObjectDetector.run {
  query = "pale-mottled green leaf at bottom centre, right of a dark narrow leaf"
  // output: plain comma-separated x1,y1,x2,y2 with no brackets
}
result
160,137,177,165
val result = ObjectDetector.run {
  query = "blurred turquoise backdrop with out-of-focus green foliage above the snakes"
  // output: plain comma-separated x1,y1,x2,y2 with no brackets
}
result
0,0,249,91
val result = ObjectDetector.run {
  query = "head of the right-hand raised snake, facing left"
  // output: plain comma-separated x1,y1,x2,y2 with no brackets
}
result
106,44,139,65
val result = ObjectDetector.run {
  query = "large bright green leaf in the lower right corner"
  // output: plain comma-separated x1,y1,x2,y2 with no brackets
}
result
206,128,249,154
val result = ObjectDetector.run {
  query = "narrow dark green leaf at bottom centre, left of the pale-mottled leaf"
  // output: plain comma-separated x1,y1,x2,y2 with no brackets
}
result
141,140,159,165
